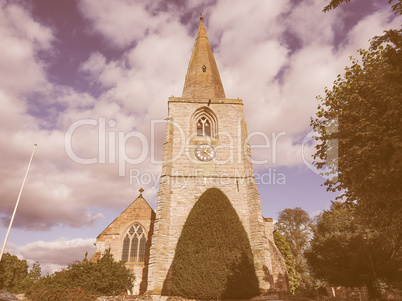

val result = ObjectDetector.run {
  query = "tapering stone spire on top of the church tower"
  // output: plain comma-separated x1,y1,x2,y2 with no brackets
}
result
182,12,226,98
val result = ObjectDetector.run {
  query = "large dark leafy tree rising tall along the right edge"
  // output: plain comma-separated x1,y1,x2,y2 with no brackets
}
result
311,30,402,257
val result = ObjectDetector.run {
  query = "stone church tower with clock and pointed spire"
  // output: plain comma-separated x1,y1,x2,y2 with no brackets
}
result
148,17,286,294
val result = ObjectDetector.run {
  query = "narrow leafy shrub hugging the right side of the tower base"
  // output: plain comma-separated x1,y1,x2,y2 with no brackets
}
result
274,230,301,295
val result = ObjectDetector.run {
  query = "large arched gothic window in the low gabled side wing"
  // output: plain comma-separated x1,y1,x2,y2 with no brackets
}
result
121,223,147,262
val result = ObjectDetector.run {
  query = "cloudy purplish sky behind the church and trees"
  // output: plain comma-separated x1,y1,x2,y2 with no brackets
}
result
0,0,401,273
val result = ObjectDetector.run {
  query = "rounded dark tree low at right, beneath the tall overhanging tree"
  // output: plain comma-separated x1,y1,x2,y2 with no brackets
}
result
305,202,401,297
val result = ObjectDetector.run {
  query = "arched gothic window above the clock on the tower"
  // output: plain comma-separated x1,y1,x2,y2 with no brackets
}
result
192,107,218,138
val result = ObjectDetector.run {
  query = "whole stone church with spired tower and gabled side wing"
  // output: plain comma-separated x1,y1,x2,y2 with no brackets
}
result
91,16,289,296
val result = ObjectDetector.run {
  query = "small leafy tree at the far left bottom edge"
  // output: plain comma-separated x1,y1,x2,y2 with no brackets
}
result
0,253,28,293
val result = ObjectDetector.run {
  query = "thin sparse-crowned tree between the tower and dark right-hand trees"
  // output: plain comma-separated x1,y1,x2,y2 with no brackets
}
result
274,207,312,288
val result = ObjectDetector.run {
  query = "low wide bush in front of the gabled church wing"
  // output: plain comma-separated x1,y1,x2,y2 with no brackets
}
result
27,249,134,297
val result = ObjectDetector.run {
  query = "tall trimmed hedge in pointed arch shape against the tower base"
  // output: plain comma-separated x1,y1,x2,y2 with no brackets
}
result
170,188,260,300
